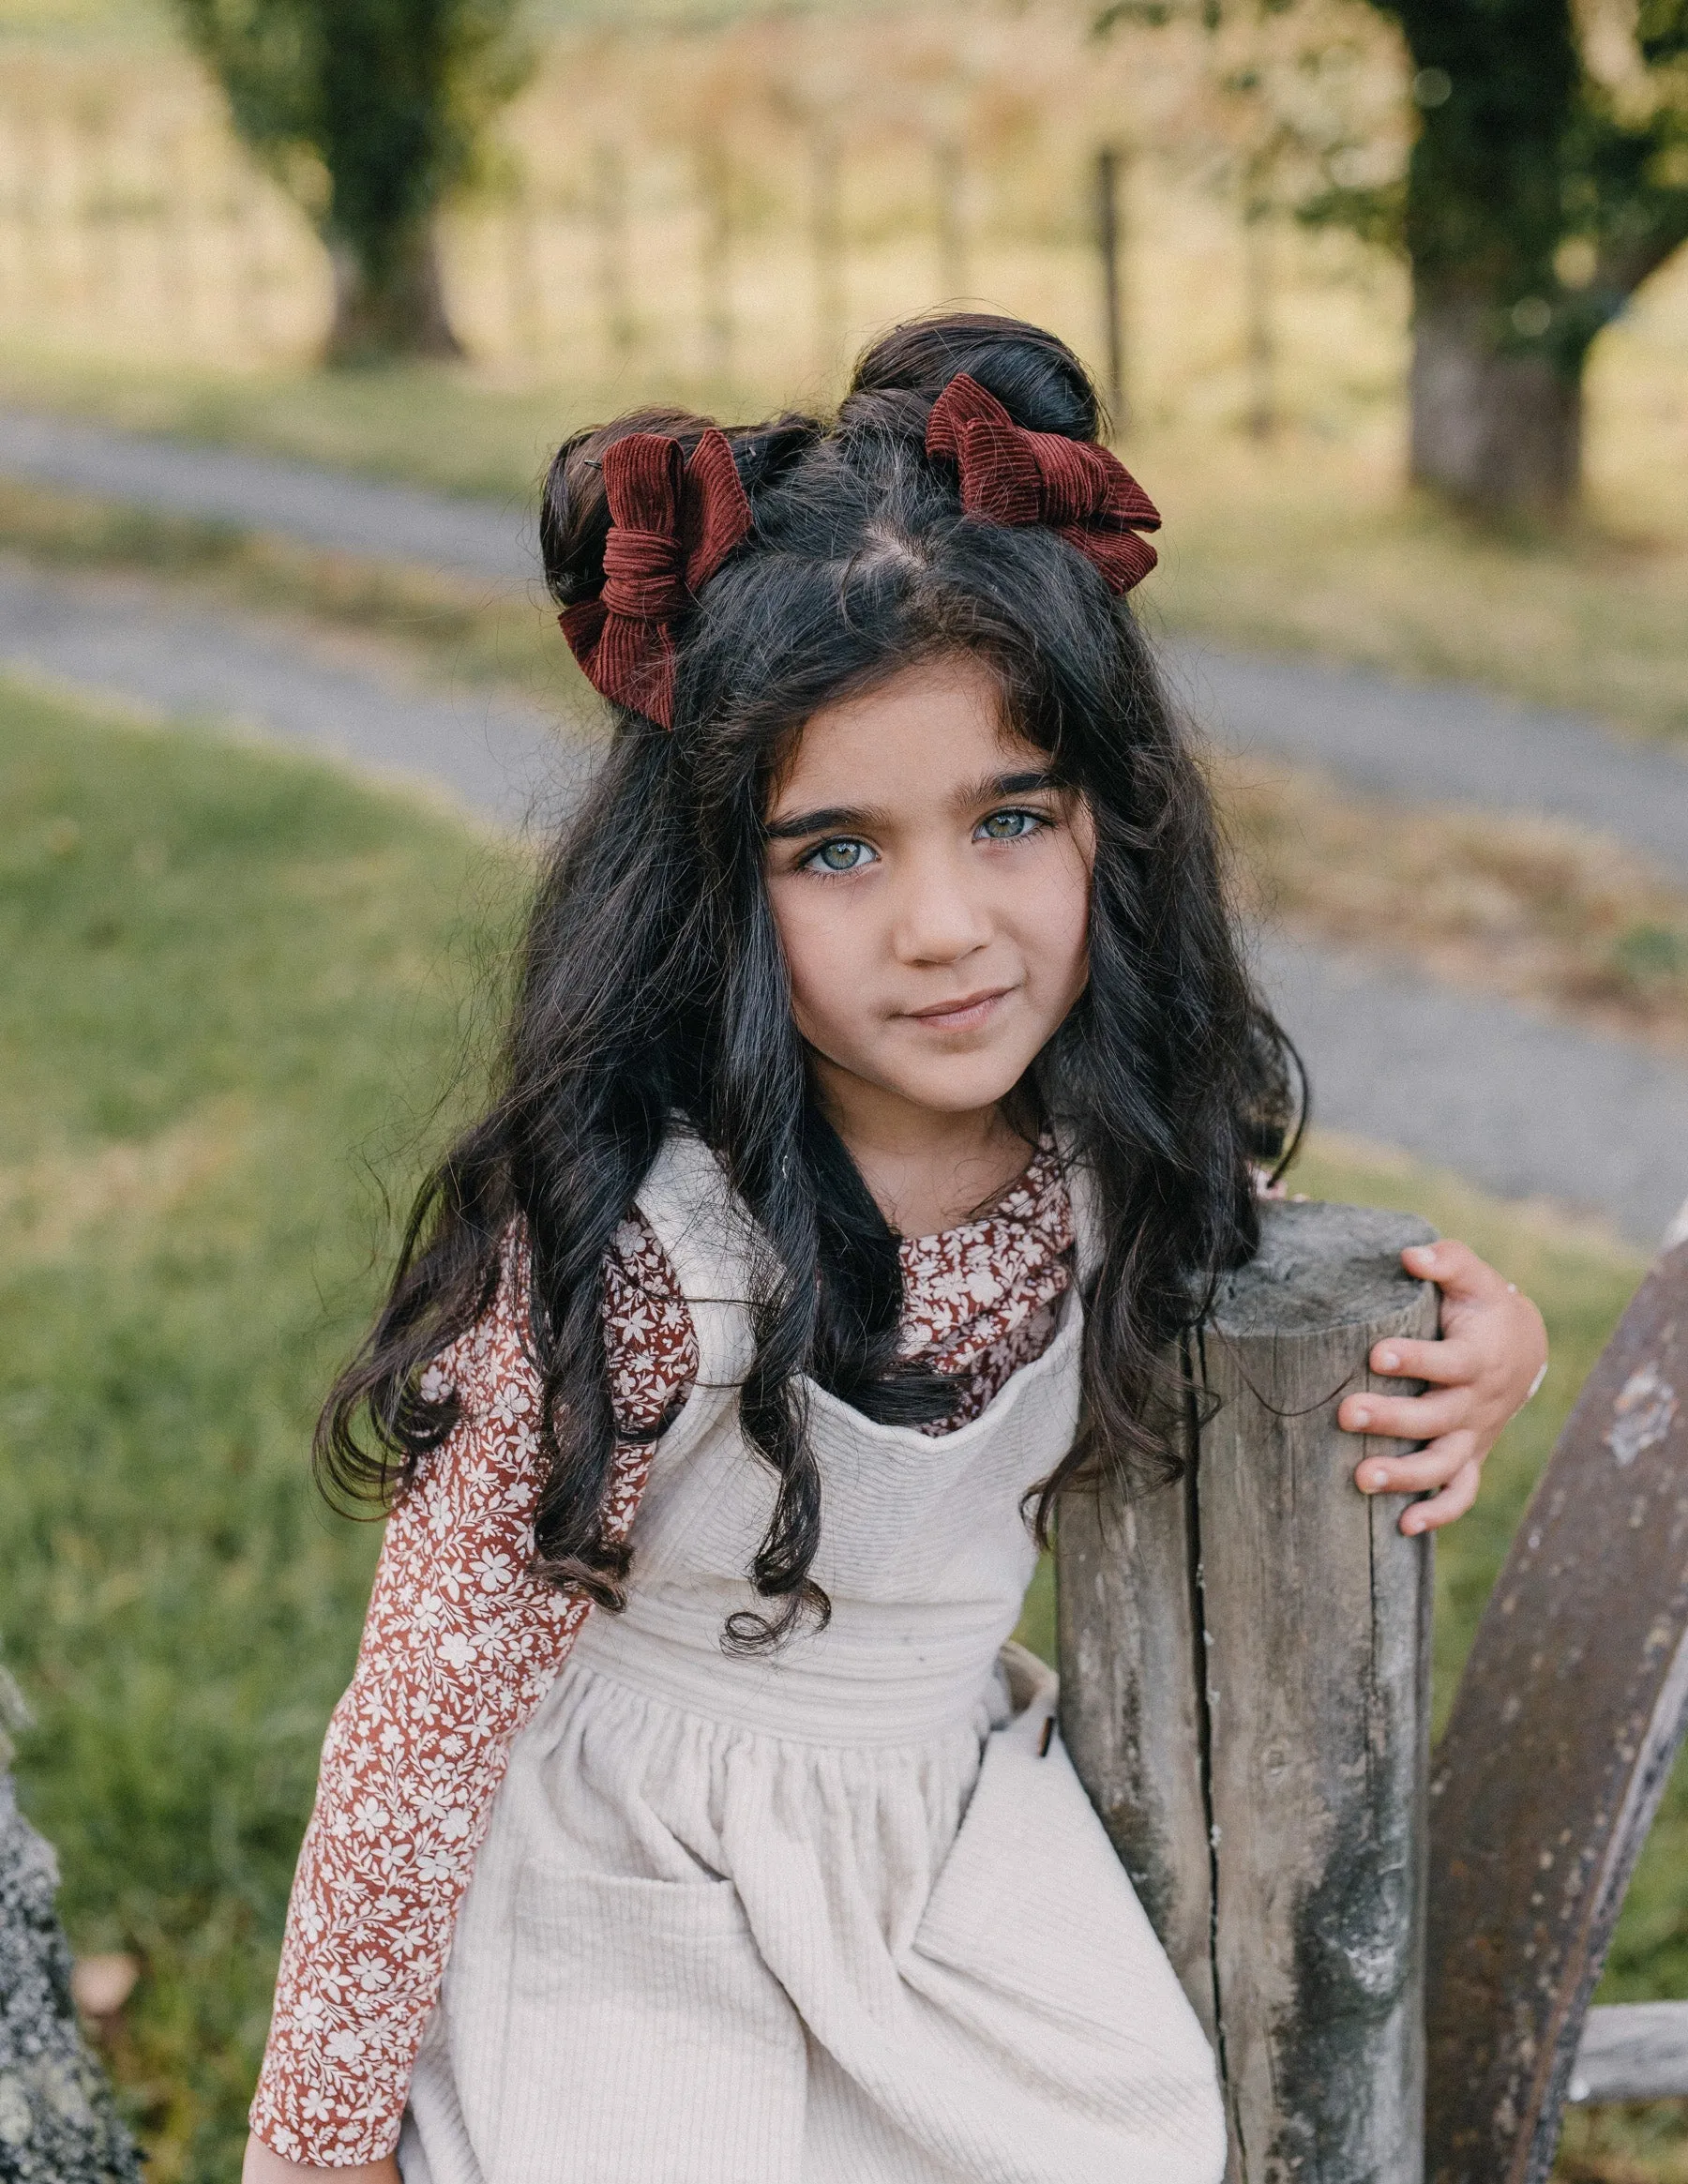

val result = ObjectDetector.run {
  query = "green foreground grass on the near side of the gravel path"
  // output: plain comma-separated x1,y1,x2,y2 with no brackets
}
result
0,688,1688,2184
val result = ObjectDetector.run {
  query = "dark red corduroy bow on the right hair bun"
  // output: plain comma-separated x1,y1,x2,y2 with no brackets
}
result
926,371,1159,592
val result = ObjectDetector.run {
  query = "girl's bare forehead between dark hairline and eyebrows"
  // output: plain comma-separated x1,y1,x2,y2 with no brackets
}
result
769,655,1046,817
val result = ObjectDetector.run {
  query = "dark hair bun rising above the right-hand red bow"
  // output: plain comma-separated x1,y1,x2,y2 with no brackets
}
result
843,310,1103,441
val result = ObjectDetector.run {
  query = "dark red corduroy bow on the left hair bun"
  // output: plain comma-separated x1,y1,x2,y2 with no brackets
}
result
557,426,753,728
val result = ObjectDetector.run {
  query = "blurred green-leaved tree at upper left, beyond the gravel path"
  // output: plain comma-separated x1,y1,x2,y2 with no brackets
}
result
177,0,529,363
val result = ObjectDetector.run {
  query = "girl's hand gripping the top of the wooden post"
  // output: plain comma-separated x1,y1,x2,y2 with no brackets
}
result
1336,1243,1548,1533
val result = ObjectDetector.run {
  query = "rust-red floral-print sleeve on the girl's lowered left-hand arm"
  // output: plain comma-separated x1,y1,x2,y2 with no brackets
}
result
249,1231,697,2179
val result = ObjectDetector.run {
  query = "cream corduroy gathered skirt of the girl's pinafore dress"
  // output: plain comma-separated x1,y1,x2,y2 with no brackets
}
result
399,1634,1225,2184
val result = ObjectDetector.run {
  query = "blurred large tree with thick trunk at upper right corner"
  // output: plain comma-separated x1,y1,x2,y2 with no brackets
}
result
1098,0,1688,513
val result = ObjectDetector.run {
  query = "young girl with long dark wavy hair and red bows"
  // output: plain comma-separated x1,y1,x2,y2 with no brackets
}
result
247,317,1544,2184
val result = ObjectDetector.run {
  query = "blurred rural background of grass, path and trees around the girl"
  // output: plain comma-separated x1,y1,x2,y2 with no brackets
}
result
0,0,1688,2184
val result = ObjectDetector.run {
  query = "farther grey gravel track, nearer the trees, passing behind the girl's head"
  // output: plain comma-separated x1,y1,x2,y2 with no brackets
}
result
0,411,1688,881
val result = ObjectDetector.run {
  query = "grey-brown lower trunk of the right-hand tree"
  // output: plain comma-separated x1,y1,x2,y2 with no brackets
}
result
1410,294,1583,516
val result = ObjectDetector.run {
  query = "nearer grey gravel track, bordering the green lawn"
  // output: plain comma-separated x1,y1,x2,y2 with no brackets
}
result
0,428,1688,1245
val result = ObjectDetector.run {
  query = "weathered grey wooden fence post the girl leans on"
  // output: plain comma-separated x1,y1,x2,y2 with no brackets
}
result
1057,1206,1437,2184
